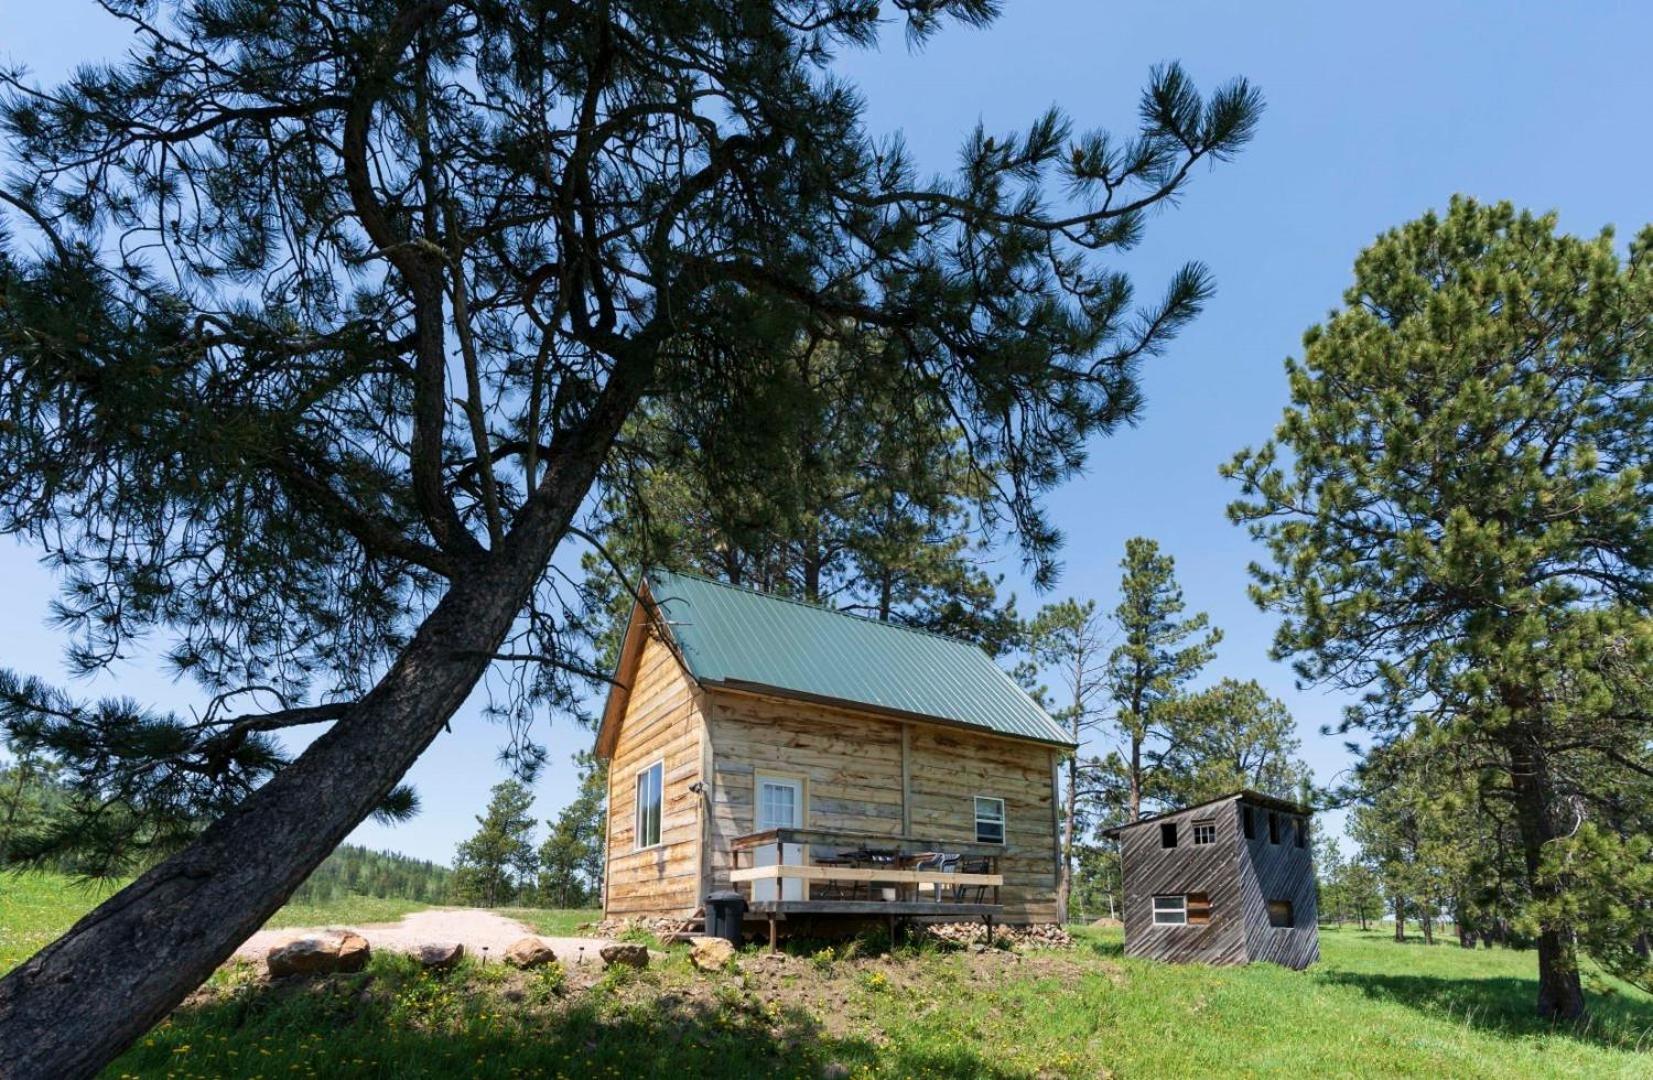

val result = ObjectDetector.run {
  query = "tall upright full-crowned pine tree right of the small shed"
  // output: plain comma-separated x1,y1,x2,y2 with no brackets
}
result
1227,198,1653,1017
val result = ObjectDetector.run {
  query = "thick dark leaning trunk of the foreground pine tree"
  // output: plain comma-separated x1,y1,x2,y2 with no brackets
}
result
0,354,653,1080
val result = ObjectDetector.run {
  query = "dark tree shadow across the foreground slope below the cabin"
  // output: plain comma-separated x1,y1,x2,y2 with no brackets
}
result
109,958,1012,1080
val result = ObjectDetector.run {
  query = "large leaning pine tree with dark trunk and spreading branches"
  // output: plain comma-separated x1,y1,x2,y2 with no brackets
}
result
0,0,1260,1078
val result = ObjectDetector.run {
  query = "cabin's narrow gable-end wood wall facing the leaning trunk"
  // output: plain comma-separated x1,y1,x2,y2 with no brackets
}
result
603,633,704,916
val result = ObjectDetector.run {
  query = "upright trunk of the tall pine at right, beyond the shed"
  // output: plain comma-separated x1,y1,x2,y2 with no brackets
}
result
1506,726,1585,1020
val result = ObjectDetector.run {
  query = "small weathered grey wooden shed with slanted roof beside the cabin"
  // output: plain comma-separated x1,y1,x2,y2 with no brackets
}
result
1106,791,1321,971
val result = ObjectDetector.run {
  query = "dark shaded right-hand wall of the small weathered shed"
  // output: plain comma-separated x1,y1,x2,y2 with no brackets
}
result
1240,809,1321,971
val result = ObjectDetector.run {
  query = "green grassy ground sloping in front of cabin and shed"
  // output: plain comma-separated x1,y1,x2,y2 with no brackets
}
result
0,878,1653,1078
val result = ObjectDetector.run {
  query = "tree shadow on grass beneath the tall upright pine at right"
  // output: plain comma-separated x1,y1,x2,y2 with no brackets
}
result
1319,971,1653,1050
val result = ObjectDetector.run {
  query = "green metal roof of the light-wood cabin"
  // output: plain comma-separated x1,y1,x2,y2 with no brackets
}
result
648,571,1073,746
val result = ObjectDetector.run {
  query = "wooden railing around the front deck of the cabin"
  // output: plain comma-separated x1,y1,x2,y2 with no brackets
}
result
729,829,1005,906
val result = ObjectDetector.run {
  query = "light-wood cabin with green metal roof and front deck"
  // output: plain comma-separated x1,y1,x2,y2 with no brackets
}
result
597,572,1073,938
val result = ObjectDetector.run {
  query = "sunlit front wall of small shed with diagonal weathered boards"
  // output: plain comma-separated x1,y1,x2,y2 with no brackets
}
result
1121,802,1246,964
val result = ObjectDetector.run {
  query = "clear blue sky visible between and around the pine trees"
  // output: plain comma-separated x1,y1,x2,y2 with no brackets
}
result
0,0,1653,862
